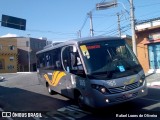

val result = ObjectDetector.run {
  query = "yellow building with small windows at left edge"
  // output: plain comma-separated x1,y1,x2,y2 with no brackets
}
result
0,37,18,73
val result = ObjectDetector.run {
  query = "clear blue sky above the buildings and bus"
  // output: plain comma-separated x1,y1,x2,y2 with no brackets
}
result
0,0,160,41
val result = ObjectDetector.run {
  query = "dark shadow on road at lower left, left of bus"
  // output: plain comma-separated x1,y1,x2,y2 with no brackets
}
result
0,86,71,111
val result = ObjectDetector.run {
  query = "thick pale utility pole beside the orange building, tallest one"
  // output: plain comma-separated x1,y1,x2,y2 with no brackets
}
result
129,0,137,56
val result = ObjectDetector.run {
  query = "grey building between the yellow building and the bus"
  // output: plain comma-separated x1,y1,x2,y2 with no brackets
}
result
17,37,47,72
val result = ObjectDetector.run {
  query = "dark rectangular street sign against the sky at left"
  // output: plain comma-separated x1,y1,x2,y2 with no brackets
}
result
1,15,26,30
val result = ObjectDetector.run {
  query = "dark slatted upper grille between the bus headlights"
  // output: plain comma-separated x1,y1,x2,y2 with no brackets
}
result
108,82,139,94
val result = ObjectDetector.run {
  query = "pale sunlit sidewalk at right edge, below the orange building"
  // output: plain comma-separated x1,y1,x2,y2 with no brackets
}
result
145,73,160,87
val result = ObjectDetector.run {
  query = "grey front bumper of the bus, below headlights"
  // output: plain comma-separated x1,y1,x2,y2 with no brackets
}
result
85,86,148,107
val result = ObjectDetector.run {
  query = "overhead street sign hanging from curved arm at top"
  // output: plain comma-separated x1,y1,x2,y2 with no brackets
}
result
96,0,117,10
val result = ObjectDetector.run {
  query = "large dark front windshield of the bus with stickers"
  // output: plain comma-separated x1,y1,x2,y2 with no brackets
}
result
80,39,142,80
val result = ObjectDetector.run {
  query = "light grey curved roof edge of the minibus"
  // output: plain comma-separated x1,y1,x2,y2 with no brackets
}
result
36,36,121,54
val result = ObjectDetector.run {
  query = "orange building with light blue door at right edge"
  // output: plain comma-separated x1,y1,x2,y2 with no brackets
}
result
136,18,160,72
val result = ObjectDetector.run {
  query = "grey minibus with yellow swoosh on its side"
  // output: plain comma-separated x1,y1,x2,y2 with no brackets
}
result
36,37,147,108
